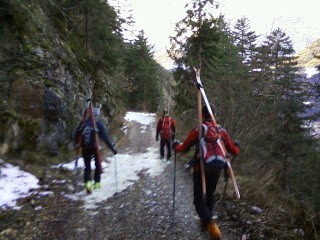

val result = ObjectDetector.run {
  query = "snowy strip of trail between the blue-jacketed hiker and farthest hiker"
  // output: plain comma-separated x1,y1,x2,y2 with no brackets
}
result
63,112,167,213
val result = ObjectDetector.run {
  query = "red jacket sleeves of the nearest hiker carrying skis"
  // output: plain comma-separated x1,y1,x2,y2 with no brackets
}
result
174,124,240,156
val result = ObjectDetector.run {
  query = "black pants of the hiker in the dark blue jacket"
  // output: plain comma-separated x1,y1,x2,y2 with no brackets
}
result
82,148,101,183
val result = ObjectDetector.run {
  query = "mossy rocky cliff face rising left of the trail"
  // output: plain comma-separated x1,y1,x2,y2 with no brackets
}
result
0,2,101,161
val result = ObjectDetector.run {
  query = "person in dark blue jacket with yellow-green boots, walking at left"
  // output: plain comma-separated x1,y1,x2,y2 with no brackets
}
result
75,108,117,192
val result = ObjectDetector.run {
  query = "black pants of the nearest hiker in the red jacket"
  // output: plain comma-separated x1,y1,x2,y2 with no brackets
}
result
193,161,224,224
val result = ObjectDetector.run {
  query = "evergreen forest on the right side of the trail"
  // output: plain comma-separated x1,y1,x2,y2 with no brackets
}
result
169,0,320,208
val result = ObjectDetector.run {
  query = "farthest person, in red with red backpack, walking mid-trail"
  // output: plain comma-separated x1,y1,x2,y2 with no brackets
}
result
156,109,176,160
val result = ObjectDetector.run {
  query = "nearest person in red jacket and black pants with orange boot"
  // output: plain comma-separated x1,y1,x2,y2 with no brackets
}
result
172,105,240,240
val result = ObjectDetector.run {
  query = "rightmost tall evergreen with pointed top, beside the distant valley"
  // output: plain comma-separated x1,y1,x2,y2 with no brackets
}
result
261,29,316,193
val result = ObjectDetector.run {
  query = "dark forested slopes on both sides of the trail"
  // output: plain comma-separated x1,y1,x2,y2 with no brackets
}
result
0,0,320,236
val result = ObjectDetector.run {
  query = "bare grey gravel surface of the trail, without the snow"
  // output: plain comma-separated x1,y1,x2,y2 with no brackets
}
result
0,113,241,240
